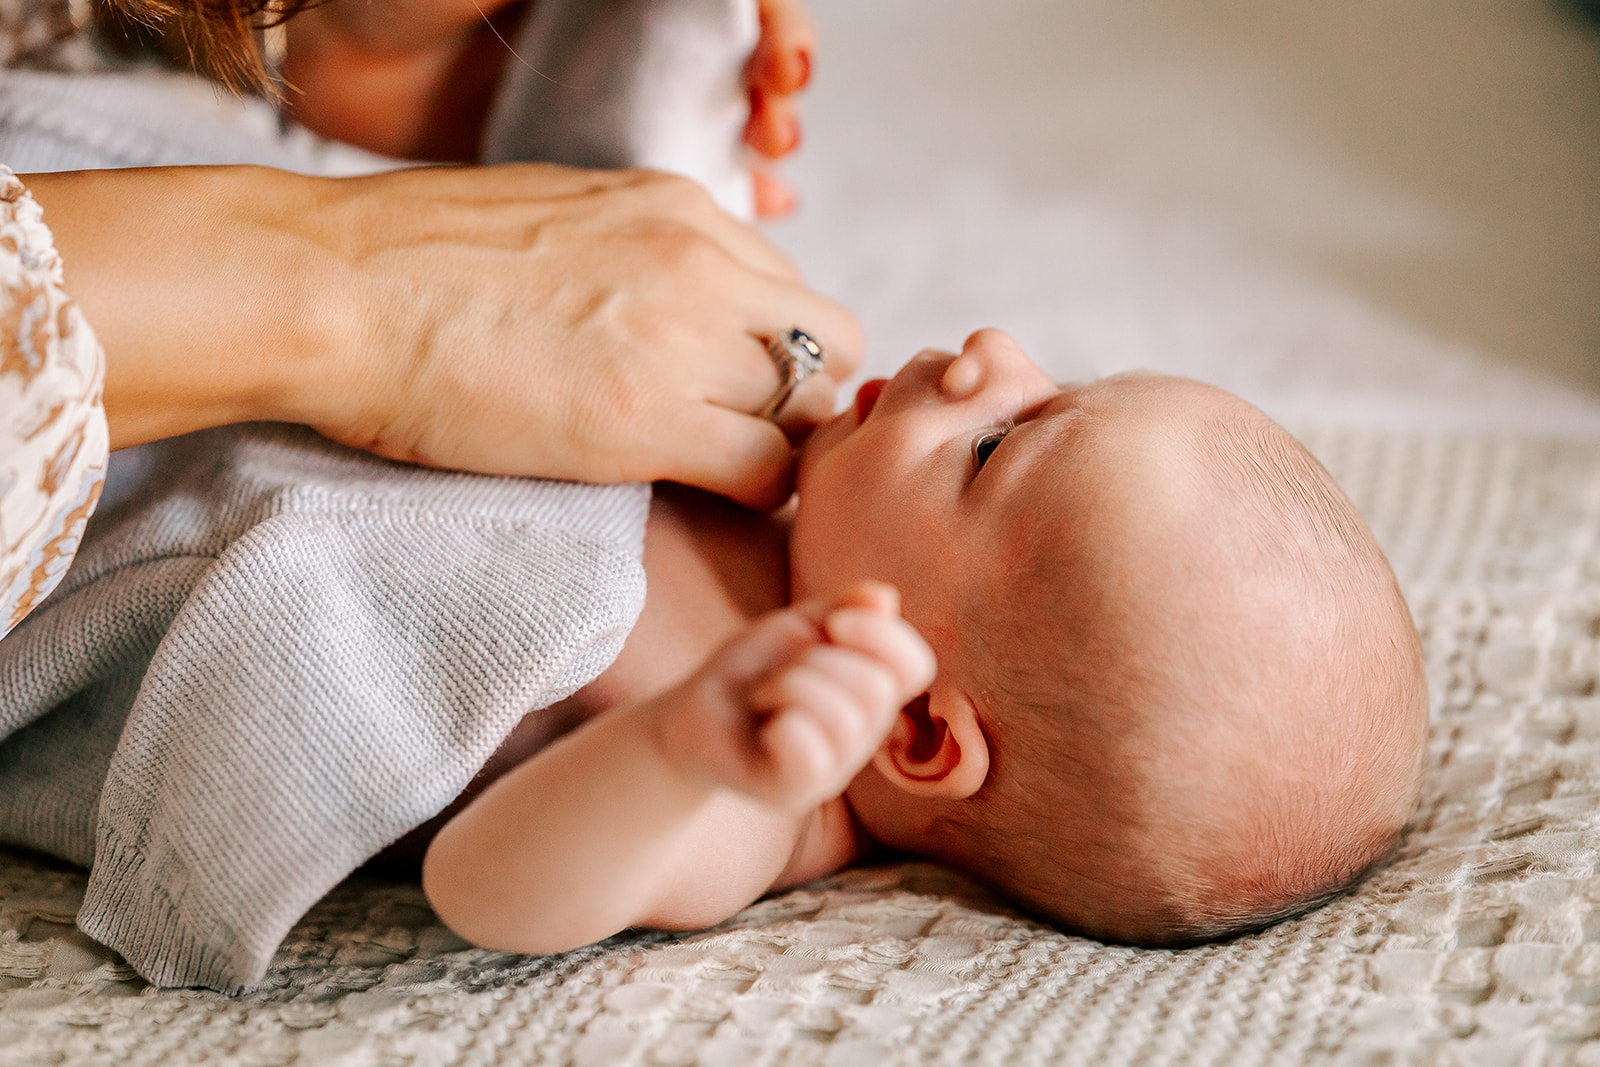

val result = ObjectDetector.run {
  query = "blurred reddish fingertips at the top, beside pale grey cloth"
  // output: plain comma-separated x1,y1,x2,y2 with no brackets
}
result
744,0,816,218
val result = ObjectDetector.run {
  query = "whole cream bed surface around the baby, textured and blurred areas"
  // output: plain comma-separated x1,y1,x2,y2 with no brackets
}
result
0,0,1600,1067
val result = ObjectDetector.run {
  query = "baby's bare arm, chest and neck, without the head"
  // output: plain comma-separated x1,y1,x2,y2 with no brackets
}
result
424,488,933,952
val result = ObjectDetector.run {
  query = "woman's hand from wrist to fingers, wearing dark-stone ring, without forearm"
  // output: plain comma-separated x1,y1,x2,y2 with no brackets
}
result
307,165,862,507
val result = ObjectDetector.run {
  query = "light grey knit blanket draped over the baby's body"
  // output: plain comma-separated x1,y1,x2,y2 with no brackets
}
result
0,426,650,990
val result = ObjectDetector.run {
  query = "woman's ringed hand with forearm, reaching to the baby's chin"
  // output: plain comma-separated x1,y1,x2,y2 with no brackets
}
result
27,165,861,507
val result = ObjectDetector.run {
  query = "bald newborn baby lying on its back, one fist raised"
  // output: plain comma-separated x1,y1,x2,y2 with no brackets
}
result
424,331,1427,952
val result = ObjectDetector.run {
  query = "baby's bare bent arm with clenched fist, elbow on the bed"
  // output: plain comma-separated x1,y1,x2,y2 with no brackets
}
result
422,584,933,952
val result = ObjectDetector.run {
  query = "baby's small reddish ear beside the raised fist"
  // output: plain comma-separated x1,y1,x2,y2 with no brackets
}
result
872,683,989,800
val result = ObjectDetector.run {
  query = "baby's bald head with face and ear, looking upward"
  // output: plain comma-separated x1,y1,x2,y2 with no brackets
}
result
790,331,1427,944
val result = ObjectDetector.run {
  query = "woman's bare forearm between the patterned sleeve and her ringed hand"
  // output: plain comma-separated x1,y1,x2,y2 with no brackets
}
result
26,166,352,448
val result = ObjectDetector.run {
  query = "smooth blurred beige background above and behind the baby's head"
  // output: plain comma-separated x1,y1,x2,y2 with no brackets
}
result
771,0,1600,437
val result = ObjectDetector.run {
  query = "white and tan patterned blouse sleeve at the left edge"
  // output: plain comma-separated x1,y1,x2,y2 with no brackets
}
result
0,165,109,637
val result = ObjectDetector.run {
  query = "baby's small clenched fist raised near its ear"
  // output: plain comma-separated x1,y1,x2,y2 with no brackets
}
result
658,582,934,813
